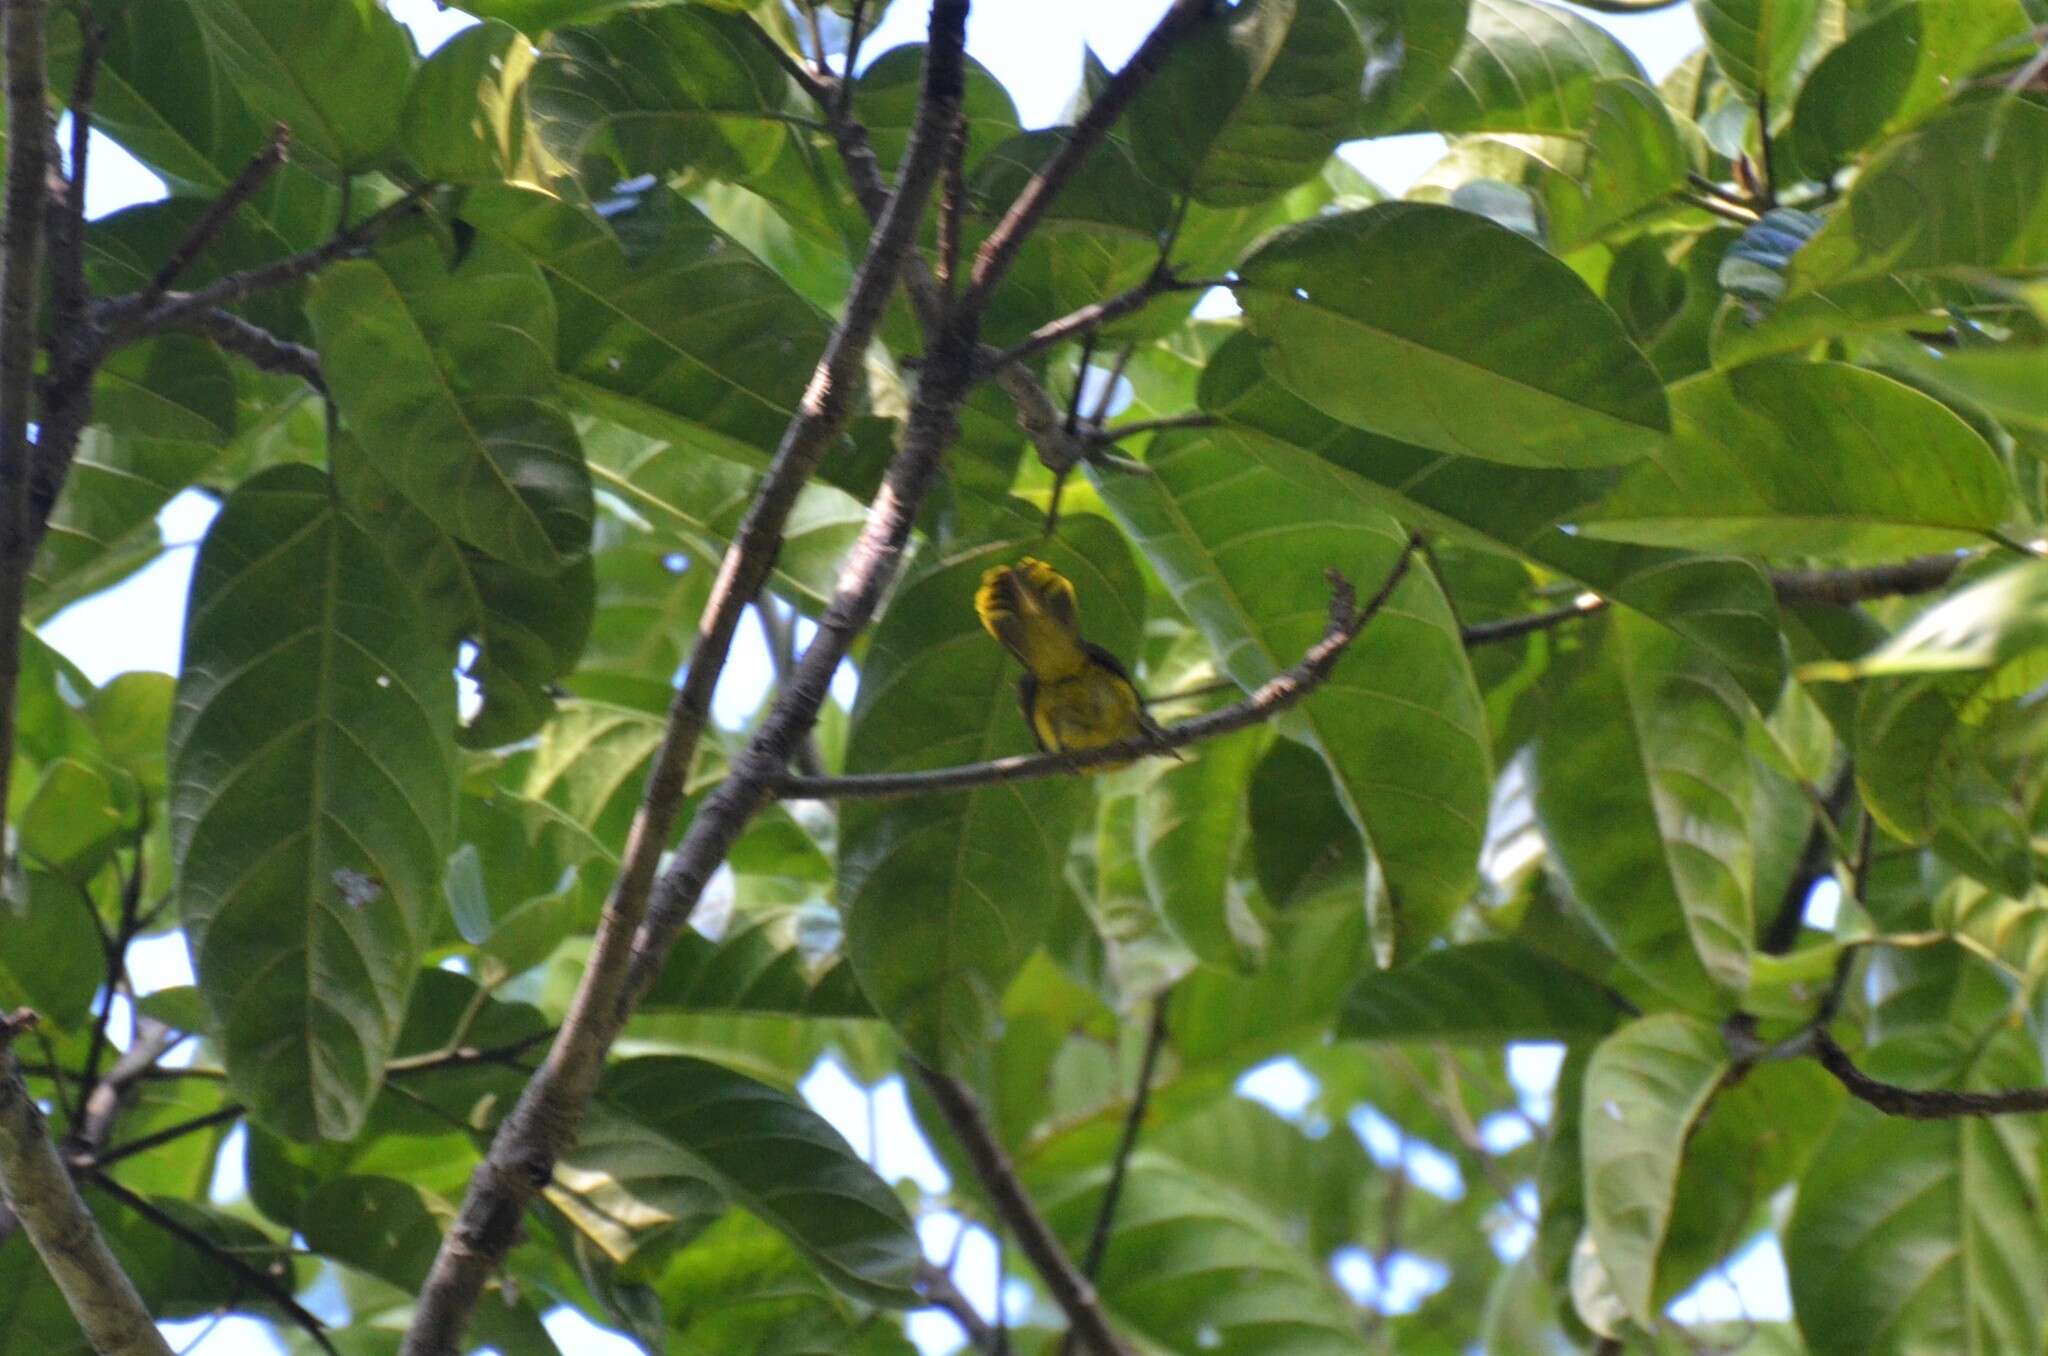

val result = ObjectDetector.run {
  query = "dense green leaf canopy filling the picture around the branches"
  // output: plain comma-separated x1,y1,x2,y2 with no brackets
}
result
12,0,2048,1354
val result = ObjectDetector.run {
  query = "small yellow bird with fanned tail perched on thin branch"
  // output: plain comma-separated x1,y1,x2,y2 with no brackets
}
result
975,555,1157,768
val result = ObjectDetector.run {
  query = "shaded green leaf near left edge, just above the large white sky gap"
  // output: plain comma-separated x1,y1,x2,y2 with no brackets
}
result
31,334,236,614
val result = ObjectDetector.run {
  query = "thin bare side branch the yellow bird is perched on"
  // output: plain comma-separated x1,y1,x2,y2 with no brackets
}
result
772,537,1417,801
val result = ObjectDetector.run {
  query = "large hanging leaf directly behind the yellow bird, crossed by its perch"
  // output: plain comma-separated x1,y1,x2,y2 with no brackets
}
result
840,514,1145,1069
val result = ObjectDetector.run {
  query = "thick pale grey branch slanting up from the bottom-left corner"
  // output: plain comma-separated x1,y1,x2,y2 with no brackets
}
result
0,1015,170,1356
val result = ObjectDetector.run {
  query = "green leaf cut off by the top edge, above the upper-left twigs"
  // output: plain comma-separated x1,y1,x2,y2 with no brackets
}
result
190,0,412,172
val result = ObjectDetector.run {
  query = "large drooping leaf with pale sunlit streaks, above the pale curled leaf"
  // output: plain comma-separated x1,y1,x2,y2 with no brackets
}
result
1536,615,1755,1010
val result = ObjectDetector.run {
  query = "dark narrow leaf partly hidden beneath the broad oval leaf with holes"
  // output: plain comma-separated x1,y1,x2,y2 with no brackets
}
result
1202,336,1786,705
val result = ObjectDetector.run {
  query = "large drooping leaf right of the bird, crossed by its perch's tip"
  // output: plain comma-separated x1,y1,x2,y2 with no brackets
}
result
1098,419,1491,948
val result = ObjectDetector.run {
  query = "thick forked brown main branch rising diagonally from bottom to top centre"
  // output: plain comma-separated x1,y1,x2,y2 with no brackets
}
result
403,13,967,1356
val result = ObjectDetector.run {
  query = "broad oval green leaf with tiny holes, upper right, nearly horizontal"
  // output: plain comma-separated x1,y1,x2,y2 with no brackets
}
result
1235,203,1671,467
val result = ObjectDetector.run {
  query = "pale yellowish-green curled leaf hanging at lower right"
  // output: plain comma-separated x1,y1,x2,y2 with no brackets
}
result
1579,1012,1729,1327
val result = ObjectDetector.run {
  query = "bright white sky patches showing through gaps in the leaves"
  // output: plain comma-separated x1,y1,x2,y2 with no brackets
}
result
43,0,1790,1356
